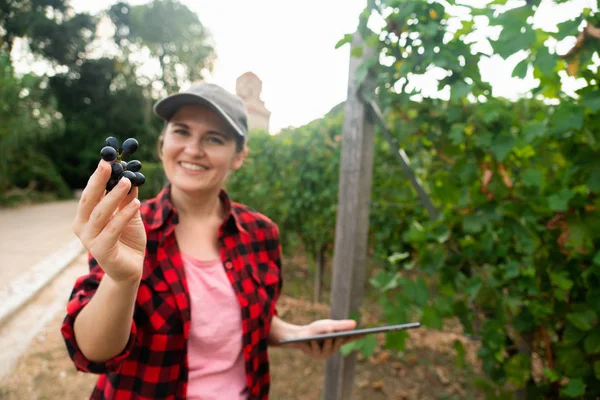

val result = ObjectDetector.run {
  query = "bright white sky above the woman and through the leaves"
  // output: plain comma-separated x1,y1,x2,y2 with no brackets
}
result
10,0,599,133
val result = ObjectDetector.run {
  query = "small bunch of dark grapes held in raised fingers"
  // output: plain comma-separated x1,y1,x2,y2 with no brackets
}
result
100,136,146,192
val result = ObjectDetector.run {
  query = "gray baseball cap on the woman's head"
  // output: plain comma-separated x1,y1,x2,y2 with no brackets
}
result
154,82,248,141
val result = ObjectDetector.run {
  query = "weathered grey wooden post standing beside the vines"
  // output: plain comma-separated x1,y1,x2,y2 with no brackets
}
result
323,33,374,400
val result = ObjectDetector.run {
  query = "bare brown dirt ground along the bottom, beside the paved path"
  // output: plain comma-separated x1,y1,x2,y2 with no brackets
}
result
0,296,482,400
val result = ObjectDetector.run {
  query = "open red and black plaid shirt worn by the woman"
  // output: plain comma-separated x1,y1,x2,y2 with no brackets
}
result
61,185,282,399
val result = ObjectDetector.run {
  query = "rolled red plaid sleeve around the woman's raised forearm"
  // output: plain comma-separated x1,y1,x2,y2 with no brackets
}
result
61,254,137,374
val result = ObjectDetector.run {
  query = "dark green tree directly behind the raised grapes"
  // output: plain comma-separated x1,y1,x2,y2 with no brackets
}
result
46,58,158,188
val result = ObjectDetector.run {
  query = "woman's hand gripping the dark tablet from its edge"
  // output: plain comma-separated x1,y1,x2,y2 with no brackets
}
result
285,319,362,360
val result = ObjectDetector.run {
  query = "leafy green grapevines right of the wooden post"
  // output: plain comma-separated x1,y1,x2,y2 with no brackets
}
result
339,0,600,399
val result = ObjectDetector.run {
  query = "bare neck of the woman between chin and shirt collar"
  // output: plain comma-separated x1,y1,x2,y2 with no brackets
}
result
171,187,224,220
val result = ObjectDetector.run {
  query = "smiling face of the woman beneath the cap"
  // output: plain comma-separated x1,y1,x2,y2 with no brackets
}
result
161,104,246,193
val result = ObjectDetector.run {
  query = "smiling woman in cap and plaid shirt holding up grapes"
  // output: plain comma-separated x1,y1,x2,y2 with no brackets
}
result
61,83,355,399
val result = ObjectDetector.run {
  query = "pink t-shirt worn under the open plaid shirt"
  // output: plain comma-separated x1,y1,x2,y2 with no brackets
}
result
181,254,248,400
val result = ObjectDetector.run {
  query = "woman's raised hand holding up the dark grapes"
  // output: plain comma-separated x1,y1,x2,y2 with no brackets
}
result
72,161,146,283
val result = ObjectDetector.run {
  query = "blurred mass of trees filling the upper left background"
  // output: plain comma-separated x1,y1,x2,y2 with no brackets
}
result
0,0,215,198
